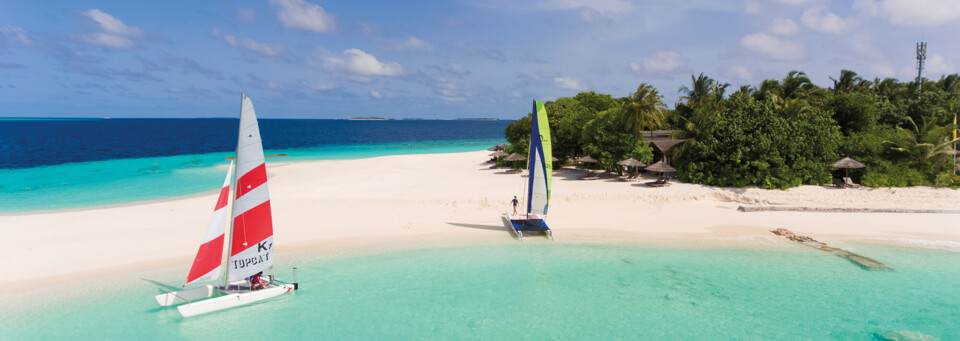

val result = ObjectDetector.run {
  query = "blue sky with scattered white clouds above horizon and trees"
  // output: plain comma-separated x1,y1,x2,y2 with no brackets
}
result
0,0,960,119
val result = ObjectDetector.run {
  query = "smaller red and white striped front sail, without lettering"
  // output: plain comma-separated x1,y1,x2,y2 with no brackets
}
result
187,162,233,285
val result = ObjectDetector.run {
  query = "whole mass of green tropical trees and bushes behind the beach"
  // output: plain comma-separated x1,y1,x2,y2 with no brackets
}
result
505,70,960,189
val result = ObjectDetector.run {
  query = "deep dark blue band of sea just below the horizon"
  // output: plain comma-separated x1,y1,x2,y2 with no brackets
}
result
0,119,510,168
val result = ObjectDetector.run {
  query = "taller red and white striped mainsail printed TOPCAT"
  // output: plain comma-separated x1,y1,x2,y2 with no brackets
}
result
227,95,273,281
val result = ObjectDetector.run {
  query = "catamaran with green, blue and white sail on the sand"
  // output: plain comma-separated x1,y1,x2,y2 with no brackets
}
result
507,101,553,240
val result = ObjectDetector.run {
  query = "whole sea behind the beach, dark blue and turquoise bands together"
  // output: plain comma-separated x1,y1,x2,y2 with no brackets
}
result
0,119,510,213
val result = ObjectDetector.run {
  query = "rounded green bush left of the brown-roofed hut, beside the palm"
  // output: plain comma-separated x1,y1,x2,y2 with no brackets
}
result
582,109,653,170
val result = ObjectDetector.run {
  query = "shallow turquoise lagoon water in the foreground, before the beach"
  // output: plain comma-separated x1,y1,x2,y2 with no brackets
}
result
0,243,960,340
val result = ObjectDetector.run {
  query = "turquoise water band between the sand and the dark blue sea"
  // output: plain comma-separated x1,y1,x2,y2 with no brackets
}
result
0,139,504,213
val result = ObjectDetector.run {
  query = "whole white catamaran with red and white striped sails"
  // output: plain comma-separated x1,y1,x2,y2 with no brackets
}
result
156,94,298,317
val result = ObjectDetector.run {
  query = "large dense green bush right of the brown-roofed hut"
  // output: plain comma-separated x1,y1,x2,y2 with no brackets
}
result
676,100,840,188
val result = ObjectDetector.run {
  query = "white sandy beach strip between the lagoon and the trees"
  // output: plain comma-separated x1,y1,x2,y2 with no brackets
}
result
0,151,960,290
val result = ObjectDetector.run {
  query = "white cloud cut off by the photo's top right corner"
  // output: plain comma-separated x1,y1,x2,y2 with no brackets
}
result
854,0,960,27
